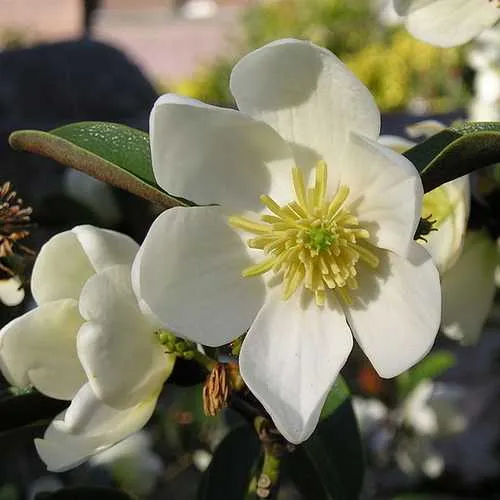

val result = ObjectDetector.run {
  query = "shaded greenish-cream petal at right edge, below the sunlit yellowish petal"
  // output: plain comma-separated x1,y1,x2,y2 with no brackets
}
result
441,231,498,344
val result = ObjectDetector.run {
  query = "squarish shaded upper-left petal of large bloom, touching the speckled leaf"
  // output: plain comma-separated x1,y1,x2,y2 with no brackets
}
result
150,94,293,211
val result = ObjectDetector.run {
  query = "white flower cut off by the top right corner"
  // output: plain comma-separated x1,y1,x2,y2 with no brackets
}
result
394,0,500,47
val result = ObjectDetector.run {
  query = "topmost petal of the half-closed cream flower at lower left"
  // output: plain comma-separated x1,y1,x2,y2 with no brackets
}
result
31,226,139,304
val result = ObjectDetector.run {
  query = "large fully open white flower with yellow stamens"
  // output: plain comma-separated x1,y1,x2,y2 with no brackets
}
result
133,40,440,443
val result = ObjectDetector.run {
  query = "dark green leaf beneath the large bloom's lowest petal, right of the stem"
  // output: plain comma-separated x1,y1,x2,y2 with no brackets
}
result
286,399,364,500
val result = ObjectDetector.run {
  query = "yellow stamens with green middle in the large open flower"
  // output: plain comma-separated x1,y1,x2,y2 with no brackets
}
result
229,162,379,306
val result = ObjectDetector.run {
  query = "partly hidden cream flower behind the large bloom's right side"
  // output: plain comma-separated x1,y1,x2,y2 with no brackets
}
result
379,136,499,344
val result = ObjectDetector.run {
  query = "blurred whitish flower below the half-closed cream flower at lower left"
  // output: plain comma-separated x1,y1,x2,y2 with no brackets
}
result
90,431,163,497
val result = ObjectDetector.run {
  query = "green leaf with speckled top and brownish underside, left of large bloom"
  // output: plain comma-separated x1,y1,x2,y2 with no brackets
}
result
9,122,182,208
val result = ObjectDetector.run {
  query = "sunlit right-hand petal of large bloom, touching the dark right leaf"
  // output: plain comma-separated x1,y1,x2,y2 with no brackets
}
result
340,133,424,256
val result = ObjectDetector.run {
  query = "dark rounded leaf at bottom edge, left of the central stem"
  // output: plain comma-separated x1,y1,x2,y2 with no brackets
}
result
197,425,260,500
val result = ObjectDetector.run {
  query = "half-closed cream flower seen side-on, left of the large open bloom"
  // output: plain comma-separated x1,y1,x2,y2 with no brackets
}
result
0,226,173,471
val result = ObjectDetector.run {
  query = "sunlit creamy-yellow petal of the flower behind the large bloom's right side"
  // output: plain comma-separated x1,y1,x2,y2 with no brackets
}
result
419,177,470,273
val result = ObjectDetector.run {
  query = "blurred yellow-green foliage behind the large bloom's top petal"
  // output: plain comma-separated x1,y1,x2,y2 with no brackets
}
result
171,0,465,112
